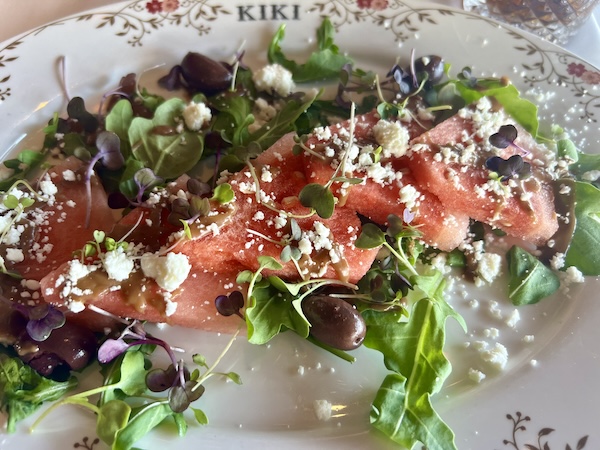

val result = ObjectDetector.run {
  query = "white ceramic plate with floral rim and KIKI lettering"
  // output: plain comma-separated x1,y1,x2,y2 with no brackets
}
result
0,0,600,450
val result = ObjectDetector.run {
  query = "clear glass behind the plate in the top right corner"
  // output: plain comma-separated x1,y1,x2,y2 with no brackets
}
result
463,0,600,44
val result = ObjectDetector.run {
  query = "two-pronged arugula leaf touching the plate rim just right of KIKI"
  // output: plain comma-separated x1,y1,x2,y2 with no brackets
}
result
267,18,352,83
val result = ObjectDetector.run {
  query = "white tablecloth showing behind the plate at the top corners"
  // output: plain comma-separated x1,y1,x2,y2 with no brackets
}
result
0,0,600,68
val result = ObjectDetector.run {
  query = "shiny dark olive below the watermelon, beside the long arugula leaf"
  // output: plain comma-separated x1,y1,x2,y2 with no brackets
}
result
302,295,367,350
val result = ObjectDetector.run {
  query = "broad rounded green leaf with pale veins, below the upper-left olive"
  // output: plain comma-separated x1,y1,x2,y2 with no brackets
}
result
128,98,204,179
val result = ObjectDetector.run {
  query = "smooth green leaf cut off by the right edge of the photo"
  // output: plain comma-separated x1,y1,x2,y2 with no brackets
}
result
565,181,600,275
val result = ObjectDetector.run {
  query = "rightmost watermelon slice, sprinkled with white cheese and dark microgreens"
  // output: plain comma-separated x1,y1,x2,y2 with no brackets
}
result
409,108,558,244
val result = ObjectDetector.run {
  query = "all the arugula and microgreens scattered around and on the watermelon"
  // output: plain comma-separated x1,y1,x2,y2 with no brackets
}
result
0,15,600,450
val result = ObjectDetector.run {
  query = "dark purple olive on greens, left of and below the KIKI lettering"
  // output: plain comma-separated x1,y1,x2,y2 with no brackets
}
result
181,52,233,95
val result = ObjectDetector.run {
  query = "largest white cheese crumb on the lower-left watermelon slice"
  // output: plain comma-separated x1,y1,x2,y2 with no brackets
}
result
141,253,192,292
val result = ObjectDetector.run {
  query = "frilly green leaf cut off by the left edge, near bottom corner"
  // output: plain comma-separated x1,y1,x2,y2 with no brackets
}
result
0,353,77,433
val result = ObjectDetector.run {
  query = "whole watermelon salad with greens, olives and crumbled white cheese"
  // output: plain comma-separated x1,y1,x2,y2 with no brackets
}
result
0,20,600,449
